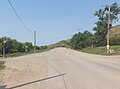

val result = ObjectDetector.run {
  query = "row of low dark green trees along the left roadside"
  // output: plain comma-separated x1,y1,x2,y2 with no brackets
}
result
0,37,47,56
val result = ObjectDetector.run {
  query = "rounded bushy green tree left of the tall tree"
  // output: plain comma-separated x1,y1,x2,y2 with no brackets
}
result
70,31,93,50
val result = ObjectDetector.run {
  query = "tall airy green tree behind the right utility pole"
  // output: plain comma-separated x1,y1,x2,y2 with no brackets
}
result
93,2,120,46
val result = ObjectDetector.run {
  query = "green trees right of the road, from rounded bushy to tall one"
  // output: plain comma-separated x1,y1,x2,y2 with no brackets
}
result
70,2,120,49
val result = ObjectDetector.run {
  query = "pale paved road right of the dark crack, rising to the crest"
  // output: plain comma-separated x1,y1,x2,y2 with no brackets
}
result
44,48,120,89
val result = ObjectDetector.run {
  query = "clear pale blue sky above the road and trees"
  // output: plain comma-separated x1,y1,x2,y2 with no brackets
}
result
0,0,120,46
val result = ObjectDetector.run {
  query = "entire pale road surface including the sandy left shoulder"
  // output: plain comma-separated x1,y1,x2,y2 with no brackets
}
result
2,48,120,89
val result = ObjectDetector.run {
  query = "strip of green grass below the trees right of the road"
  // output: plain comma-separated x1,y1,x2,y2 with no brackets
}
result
81,45,120,55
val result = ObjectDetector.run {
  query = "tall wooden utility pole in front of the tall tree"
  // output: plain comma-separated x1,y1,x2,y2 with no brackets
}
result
107,6,111,54
